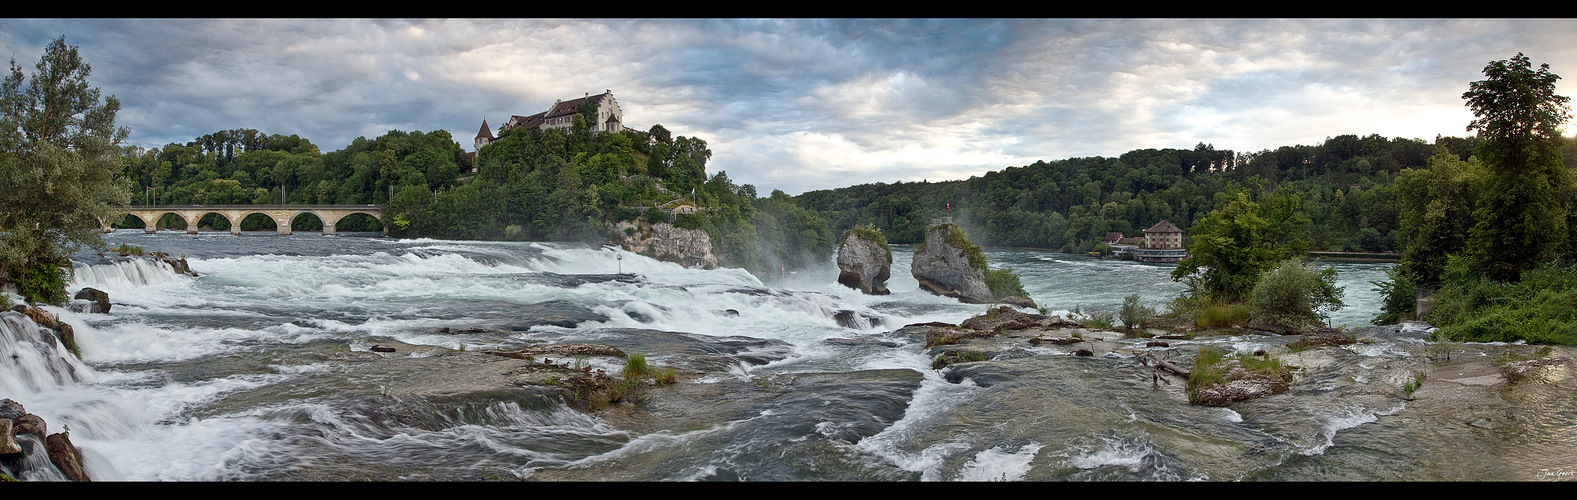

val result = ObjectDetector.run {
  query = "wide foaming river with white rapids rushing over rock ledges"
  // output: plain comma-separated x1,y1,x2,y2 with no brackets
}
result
0,230,1577,481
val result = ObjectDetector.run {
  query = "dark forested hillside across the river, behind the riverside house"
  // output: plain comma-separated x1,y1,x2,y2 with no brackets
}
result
796,134,1577,252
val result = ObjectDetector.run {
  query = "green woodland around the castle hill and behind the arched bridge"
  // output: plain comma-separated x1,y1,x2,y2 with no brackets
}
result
121,107,837,271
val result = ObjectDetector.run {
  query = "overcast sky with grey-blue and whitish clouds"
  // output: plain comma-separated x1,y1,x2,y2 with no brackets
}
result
0,19,1577,194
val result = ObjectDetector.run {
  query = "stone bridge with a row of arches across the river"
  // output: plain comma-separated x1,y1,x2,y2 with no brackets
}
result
103,205,390,235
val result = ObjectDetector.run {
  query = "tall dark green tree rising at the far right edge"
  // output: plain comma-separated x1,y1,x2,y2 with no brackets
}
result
1462,52,1571,282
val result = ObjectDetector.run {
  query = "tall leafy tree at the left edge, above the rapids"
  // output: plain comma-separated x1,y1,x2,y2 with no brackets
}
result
0,36,131,303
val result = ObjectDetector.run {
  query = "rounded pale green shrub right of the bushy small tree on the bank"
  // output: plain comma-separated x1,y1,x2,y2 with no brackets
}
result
1249,260,1342,328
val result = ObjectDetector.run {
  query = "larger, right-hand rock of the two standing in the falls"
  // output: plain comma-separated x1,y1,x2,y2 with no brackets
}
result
908,222,992,304
